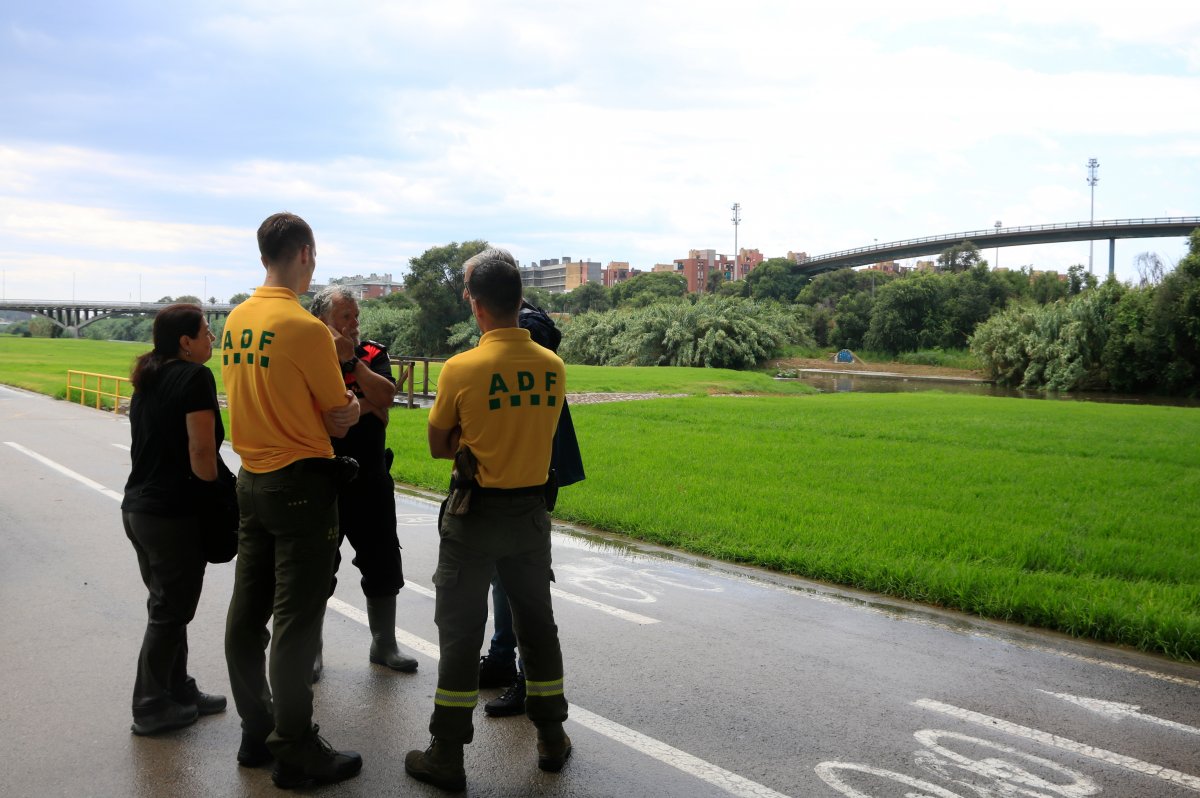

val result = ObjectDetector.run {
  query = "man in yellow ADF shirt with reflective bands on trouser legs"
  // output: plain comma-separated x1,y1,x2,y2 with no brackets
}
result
404,250,571,790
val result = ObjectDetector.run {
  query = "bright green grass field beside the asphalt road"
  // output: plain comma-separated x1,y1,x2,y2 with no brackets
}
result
9,337,1200,661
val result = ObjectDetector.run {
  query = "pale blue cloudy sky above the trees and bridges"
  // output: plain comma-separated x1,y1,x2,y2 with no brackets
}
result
0,0,1200,301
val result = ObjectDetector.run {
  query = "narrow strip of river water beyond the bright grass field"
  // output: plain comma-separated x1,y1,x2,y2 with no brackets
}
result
797,371,1200,407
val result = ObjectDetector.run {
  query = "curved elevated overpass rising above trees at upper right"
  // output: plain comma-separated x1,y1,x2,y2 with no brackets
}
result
799,216,1200,276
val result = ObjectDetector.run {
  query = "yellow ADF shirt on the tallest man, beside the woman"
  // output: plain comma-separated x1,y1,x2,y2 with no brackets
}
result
221,286,346,474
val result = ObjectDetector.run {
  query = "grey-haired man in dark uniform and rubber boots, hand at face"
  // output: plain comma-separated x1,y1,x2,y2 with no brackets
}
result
308,284,418,676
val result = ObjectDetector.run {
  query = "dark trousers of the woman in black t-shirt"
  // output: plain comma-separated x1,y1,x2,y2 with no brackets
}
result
121,512,208,718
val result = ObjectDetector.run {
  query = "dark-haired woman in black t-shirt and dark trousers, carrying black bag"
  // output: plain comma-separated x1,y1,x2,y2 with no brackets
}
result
121,305,226,734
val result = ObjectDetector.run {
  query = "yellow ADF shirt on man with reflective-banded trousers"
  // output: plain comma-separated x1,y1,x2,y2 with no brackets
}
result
430,328,566,487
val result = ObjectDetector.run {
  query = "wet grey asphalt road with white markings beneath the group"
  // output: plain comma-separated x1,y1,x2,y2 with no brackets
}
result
0,388,1200,798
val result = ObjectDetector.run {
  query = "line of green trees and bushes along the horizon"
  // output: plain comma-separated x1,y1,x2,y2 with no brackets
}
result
10,230,1200,395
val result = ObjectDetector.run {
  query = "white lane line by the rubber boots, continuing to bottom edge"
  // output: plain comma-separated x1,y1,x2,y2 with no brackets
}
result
329,597,787,798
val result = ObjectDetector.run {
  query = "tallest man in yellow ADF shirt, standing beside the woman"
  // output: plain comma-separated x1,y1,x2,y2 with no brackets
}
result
221,214,362,788
